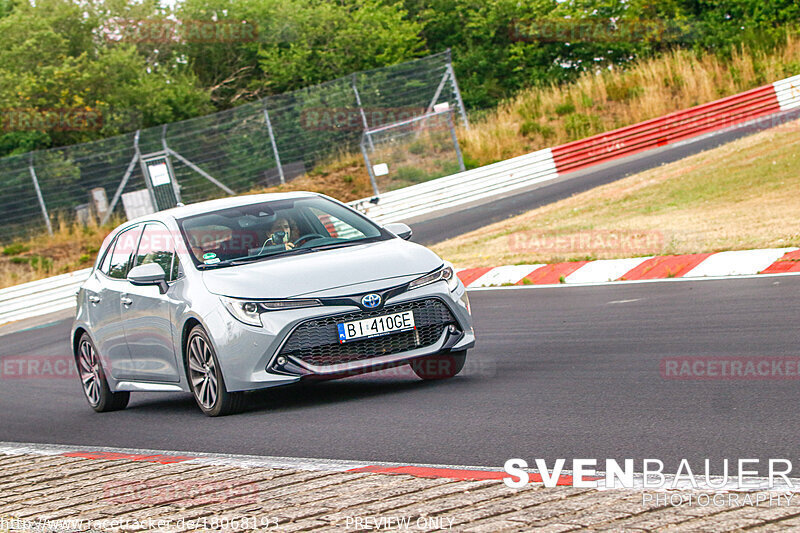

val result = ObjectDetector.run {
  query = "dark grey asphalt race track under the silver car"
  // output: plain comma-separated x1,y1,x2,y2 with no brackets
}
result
0,276,800,474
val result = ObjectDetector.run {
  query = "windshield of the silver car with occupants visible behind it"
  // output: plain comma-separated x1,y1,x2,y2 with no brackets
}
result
178,197,389,268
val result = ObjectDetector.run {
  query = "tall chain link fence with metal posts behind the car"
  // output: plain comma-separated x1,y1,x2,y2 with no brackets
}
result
0,51,467,241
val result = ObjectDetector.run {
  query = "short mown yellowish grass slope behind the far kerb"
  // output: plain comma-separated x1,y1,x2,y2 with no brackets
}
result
434,117,800,267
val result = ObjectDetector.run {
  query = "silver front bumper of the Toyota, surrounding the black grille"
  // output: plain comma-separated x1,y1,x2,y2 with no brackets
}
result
206,281,475,392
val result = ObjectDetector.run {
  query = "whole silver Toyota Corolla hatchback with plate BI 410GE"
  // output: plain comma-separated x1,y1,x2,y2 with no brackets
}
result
71,193,475,416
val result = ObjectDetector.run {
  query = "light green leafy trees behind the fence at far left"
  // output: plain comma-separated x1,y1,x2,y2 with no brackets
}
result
0,0,213,155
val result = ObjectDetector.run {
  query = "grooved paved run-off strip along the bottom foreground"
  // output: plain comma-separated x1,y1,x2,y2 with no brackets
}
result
0,453,800,532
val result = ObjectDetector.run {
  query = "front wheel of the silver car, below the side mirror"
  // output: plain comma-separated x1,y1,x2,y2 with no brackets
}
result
184,325,244,417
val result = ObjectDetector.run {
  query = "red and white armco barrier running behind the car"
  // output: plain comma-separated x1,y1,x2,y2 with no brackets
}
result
0,76,800,324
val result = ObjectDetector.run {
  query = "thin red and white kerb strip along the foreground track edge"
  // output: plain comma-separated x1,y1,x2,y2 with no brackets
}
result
6,442,800,493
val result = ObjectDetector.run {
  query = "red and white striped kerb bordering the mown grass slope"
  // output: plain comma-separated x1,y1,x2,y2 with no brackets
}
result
456,248,800,289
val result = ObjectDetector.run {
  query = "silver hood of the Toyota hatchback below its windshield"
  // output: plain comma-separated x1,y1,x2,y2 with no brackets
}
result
202,239,443,298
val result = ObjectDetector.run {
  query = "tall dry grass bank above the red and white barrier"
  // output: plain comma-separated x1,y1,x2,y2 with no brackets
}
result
459,37,800,165
